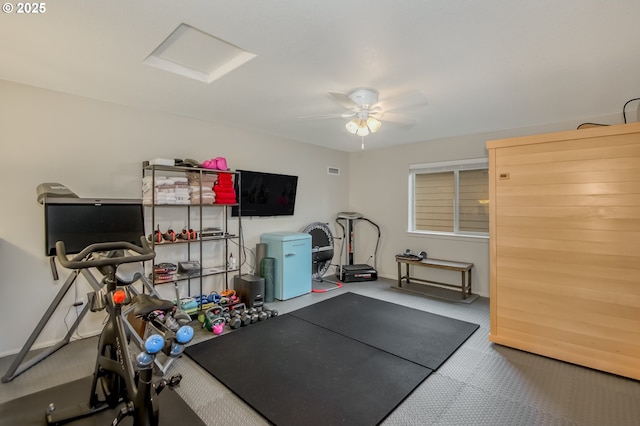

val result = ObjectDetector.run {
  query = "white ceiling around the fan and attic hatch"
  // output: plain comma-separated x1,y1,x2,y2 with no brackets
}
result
0,0,640,151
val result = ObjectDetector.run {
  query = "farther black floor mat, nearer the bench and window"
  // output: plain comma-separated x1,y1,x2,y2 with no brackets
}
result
290,293,480,371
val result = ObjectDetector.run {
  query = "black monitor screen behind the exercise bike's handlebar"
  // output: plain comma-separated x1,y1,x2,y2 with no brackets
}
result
44,198,144,256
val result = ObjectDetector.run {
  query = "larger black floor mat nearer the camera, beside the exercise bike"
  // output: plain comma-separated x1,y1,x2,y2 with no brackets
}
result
183,315,432,426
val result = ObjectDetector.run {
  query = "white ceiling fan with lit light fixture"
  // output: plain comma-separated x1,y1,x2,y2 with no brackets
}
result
299,87,427,136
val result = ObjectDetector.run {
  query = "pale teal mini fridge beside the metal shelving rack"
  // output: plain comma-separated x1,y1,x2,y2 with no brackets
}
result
260,232,312,300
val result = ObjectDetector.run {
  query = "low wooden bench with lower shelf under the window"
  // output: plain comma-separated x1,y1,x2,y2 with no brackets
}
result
396,256,473,300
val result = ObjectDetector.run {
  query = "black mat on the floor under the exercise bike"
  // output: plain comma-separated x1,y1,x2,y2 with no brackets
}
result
0,377,204,426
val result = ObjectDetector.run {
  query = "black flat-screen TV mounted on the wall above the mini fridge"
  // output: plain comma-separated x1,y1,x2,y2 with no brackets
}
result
231,170,298,216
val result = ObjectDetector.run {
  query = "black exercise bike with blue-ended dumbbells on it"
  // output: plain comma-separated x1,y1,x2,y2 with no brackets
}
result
46,237,194,426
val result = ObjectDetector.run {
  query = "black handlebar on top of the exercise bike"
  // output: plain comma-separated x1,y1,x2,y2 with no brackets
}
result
56,236,156,269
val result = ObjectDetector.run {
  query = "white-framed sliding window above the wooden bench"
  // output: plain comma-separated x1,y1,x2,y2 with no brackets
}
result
409,159,489,235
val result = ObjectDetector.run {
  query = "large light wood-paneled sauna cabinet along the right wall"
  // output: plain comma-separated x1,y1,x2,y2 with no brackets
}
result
487,123,640,380
